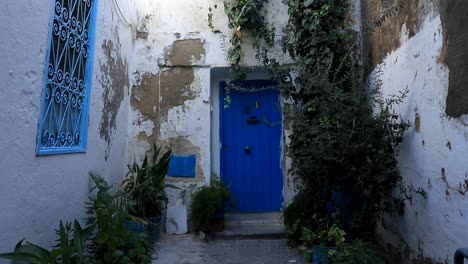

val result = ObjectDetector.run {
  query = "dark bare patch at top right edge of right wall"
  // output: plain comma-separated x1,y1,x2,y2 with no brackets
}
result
439,0,468,117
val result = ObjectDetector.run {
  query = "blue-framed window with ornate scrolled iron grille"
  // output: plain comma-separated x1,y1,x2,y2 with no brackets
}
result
37,0,97,155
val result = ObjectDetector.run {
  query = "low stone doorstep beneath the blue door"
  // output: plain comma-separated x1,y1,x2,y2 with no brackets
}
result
216,212,286,238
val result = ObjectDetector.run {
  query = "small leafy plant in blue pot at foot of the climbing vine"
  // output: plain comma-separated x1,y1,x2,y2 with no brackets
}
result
301,213,346,264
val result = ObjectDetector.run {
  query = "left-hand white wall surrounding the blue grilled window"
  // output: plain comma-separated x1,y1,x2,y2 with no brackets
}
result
0,0,133,252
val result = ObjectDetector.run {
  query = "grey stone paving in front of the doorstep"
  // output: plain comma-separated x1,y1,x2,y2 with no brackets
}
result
153,235,305,264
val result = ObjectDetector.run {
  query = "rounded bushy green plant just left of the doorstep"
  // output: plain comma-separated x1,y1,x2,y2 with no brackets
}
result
190,177,231,232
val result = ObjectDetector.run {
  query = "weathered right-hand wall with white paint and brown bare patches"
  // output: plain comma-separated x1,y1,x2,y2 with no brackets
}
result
363,0,468,263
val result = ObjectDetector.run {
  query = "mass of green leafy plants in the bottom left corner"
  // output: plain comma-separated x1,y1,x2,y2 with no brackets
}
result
0,173,153,264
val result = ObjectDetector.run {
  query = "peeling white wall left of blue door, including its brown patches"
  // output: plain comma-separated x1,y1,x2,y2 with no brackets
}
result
127,0,287,233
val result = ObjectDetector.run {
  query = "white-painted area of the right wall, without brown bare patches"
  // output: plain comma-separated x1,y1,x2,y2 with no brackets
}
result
374,9,468,263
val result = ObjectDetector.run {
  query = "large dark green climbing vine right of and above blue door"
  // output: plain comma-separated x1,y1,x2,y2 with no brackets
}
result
218,0,426,239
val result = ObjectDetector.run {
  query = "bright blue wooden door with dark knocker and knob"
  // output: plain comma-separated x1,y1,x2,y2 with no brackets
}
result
220,81,283,212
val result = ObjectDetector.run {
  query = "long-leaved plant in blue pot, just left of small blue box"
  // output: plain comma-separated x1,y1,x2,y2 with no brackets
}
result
121,145,177,240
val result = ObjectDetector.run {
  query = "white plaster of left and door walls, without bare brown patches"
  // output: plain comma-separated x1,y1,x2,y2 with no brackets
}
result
0,0,287,248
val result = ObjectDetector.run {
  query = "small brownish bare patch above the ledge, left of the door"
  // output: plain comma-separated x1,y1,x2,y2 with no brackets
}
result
165,39,205,66
